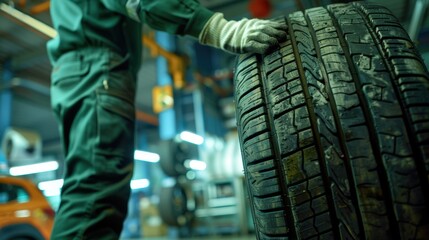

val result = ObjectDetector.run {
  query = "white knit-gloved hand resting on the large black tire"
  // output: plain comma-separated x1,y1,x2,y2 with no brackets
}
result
199,13,287,54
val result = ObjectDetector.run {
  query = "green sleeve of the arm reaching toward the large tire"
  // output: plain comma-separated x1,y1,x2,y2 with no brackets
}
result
102,0,214,38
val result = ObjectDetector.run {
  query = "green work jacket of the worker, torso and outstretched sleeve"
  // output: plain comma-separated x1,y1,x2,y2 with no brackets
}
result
48,0,214,71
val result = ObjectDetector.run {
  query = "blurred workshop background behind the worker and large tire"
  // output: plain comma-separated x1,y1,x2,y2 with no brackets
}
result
0,0,429,239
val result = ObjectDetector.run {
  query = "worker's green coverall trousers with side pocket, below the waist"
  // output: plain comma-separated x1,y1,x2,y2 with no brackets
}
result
51,47,136,240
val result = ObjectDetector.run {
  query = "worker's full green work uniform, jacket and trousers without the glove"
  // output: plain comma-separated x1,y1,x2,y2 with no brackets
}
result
48,0,213,240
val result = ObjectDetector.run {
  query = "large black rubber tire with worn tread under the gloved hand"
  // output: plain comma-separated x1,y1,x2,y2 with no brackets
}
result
235,2,429,240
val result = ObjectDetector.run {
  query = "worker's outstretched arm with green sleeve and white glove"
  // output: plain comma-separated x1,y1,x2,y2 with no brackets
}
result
102,0,286,53
